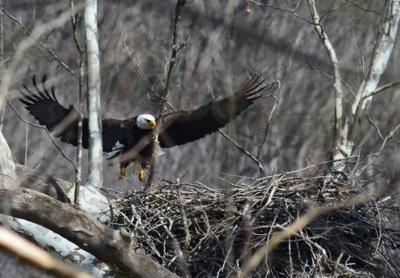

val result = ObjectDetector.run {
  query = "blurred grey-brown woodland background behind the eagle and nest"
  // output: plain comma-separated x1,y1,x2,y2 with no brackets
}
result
0,0,400,276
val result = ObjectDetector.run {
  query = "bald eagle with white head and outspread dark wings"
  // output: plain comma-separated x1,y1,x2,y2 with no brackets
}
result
19,75,266,181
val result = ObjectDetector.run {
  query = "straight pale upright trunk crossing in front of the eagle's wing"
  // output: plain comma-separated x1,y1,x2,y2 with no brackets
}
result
85,0,103,187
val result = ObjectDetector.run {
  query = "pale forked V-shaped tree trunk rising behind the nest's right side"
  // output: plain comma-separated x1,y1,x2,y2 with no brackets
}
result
308,0,400,164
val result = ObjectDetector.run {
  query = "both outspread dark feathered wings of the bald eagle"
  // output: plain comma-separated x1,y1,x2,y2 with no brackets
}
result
20,76,265,152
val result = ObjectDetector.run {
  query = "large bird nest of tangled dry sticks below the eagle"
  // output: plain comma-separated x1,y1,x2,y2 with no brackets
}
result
112,173,400,277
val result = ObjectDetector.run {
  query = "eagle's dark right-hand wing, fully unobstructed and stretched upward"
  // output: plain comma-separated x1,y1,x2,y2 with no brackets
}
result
158,76,266,148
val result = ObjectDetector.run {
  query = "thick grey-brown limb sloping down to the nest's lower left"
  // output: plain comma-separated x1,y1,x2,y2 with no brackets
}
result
0,184,178,278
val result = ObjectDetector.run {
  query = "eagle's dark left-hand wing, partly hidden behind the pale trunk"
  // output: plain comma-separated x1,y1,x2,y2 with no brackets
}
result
19,76,134,152
